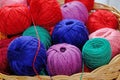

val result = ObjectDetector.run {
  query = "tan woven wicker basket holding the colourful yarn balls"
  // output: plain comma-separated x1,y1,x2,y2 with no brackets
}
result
0,0,120,80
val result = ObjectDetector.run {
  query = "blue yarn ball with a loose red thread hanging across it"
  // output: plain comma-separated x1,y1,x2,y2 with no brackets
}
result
7,36,47,76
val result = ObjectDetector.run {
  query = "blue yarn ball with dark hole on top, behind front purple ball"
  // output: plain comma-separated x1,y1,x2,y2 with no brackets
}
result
52,19,89,49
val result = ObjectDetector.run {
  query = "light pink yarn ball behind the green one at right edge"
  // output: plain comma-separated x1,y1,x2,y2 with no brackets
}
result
89,28,120,57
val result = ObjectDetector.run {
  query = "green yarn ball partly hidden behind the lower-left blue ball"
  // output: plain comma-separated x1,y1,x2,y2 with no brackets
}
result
23,26,51,49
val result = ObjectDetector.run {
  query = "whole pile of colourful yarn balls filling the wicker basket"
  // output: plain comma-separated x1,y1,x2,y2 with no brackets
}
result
0,0,120,76
